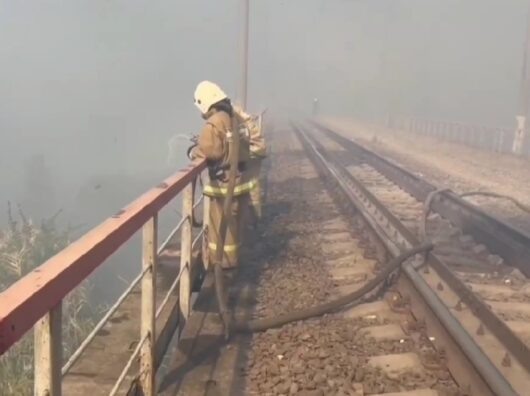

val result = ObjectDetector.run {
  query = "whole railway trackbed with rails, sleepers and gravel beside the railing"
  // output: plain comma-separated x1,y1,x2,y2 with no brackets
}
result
160,124,530,396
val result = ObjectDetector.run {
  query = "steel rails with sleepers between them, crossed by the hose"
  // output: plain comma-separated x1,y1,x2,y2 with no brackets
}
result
297,124,530,395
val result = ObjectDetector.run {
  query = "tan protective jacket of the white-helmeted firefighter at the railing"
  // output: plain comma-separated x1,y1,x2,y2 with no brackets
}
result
193,111,256,197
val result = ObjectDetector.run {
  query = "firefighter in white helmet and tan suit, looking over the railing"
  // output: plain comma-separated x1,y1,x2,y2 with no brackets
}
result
191,81,256,269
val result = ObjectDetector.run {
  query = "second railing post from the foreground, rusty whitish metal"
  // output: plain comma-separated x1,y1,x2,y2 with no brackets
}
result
140,214,158,396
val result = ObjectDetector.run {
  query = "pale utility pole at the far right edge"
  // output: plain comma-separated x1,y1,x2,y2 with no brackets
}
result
512,1,530,155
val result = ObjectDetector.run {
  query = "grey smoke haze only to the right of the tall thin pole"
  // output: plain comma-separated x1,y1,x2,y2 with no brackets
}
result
251,0,529,126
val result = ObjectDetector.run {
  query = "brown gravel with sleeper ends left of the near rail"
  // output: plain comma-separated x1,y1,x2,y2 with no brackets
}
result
240,127,462,396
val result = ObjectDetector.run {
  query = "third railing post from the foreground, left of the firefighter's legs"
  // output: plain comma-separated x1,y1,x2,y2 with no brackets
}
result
179,180,195,322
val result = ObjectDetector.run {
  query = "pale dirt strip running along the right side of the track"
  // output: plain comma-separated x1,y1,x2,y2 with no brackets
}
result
321,118,530,233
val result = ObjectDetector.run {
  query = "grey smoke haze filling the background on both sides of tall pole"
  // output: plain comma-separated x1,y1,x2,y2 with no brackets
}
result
0,0,528,296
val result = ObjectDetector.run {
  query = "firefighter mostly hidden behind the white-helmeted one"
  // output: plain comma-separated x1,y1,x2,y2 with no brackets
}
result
234,106,267,228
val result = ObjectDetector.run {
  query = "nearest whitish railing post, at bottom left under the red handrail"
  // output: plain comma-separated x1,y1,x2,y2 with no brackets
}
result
33,303,63,396
